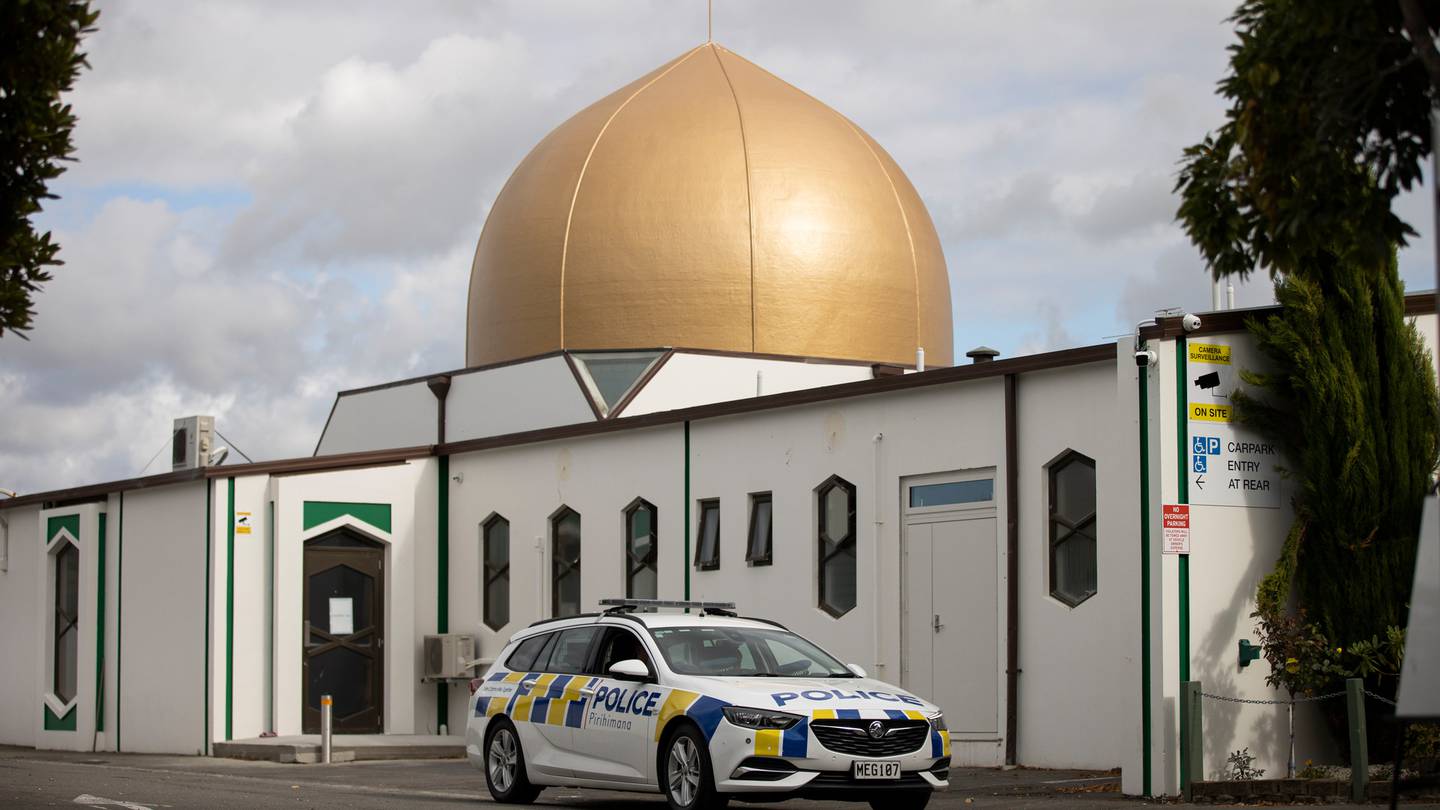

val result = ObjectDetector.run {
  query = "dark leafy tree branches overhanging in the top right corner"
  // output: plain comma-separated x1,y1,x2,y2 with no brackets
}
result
1176,0,1440,278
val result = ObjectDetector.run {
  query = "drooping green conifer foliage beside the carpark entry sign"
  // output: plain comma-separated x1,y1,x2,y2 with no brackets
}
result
1234,242,1440,646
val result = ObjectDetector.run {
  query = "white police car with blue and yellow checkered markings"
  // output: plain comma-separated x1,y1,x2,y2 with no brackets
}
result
465,600,950,810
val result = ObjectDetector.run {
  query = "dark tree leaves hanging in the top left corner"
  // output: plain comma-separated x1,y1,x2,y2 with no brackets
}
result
0,0,99,337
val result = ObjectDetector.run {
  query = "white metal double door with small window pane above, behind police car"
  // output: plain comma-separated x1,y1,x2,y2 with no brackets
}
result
901,473,999,739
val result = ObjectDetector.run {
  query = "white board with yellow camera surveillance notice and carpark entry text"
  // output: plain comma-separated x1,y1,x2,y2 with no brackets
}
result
1187,343,1280,509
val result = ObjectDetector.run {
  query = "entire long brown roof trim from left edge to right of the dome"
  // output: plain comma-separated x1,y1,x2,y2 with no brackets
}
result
0,343,1115,509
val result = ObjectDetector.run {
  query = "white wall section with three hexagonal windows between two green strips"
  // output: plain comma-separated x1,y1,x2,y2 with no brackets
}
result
449,424,688,728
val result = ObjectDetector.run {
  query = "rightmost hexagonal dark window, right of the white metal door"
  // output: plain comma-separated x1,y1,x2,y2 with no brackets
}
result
1050,450,1099,607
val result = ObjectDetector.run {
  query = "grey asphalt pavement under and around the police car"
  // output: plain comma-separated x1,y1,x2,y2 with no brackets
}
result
0,747,1428,810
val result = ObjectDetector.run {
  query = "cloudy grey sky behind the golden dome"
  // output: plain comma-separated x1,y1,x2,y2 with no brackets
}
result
0,0,1433,491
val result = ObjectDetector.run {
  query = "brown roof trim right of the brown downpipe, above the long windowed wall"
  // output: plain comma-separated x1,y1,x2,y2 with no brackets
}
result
436,343,1115,455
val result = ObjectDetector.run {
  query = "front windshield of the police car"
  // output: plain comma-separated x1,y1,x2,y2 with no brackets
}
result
651,627,855,677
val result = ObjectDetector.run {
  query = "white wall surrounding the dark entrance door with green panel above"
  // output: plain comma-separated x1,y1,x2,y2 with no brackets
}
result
270,458,432,735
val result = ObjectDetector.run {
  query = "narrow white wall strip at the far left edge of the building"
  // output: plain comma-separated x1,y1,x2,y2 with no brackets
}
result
0,506,45,745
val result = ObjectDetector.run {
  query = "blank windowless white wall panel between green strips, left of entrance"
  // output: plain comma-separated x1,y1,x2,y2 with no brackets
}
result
115,481,207,754
